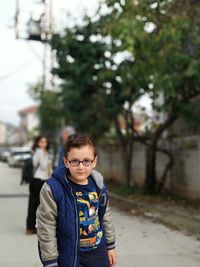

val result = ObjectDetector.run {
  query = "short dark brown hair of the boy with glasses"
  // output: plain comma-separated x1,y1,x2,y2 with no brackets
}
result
64,133,97,157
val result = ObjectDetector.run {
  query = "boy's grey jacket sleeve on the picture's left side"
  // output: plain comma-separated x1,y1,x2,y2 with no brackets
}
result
36,183,58,267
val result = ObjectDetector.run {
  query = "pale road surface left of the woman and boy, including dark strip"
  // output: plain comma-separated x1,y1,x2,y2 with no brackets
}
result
0,163,41,267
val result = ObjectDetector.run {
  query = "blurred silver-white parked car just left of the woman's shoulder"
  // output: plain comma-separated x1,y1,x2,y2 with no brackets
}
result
7,147,31,167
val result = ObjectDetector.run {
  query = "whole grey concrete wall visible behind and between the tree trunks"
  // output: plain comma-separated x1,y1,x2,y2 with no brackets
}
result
97,136,200,199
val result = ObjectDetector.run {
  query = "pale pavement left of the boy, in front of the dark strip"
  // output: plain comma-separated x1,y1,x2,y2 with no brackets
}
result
0,197,41,267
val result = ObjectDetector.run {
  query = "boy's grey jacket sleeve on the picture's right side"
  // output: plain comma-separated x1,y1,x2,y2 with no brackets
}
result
103,203,115,250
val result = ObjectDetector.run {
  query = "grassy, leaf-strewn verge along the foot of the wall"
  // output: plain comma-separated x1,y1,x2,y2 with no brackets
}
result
108,182,200,240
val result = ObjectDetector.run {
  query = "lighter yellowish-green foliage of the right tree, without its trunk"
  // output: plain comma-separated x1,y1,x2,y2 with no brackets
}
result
106,0,200,127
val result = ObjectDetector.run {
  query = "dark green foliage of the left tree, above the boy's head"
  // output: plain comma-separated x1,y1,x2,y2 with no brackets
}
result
52,19,109,137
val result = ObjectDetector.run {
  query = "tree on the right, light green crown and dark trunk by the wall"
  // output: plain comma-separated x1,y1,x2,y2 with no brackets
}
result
103,0,200,193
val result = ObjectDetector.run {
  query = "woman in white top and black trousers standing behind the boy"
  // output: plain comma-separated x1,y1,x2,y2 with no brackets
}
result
26,135,51,235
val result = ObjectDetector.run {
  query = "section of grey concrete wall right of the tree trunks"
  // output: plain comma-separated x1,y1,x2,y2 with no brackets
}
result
171,136,200,199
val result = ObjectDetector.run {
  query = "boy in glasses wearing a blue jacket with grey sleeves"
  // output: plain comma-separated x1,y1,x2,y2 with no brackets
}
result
37,134,116,267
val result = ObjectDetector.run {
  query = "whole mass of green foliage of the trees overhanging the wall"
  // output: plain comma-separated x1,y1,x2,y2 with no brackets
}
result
48,0,200,192
